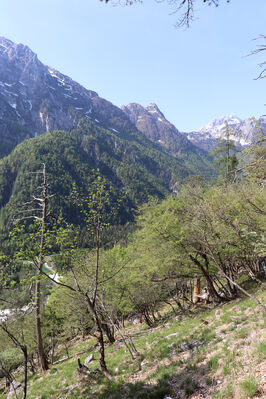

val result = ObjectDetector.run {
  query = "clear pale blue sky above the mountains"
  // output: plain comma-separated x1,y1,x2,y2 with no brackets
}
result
0,0,266,131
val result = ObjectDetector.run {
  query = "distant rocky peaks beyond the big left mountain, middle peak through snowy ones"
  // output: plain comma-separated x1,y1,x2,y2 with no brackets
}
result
121,103,266,158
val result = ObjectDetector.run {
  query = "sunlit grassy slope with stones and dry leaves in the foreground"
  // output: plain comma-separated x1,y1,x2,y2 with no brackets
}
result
0,291,266,399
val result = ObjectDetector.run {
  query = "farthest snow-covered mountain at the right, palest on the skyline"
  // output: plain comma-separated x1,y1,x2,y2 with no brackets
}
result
186,115,266,151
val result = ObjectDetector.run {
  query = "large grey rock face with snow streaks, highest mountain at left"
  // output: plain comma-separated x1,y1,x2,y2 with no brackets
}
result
0,37,134,157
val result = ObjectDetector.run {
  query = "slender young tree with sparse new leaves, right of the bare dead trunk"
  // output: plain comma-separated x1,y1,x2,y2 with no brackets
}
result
43,170,124,378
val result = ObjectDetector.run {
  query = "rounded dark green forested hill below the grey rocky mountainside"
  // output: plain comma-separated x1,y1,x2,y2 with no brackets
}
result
0,119,189,242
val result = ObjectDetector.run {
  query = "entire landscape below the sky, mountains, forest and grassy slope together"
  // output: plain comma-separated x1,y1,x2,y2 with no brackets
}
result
0,33,266,399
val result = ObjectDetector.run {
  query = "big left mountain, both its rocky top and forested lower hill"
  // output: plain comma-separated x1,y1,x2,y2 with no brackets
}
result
0,38,214,241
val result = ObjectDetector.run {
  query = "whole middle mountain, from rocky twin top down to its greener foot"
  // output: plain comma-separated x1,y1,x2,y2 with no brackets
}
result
121,103,210,173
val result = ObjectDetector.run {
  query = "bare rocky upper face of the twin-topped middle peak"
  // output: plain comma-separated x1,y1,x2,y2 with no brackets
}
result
122,103,198,155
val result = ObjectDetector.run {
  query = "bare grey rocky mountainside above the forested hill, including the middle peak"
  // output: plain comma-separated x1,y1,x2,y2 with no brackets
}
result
0,37,214,183
